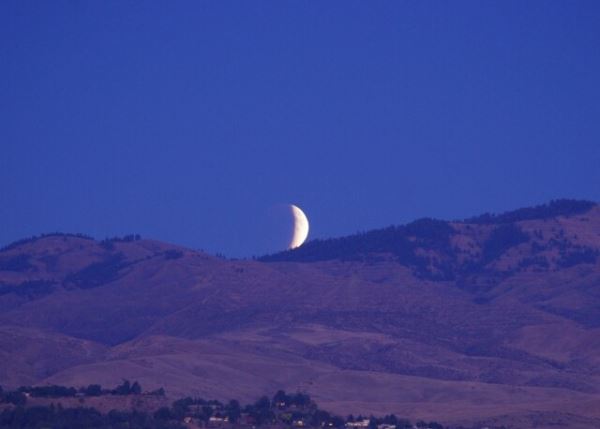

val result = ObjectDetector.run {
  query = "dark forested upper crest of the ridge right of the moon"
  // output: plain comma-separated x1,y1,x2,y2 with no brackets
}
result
259,200,599,280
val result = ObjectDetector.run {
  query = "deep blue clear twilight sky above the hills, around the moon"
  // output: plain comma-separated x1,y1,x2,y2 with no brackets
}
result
0,0,600,256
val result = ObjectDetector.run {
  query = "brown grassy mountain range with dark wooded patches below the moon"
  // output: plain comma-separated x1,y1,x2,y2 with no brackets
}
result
0,200,600,428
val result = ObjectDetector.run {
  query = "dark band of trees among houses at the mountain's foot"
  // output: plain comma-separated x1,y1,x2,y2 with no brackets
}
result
0,380,443,429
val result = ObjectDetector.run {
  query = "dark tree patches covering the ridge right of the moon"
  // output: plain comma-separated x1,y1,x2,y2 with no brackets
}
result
259,199,599,284
